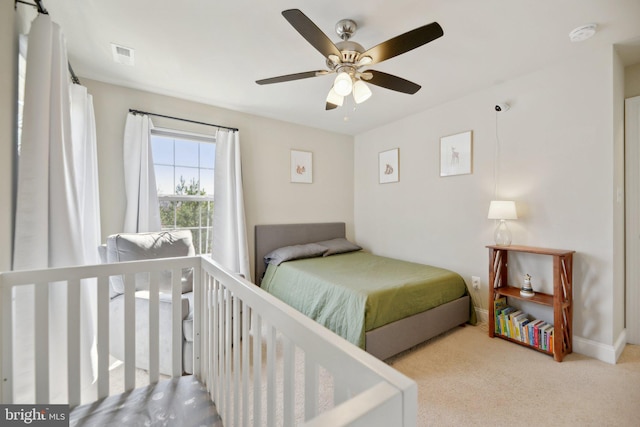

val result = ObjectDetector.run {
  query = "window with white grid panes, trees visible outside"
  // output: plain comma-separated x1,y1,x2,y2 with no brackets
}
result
151,129,216,254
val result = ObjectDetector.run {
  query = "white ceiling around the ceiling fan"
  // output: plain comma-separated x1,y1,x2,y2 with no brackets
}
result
18,0,640,134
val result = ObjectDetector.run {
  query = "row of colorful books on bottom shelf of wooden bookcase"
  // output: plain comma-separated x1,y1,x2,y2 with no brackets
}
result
493,297,553,353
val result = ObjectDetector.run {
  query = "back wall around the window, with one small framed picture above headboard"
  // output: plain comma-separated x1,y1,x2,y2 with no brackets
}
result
80,76,353,280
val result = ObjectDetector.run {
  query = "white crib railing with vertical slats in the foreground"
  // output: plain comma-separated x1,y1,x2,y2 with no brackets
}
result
0,257,417,426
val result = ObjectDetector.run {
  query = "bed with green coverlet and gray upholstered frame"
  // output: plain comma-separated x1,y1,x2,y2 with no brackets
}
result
255,222,476,360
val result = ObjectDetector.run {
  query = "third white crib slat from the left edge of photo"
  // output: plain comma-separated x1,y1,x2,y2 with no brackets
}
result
67,280,82,407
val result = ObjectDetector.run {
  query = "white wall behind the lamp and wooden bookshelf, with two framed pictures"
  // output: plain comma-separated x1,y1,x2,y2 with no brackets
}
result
354,48,624,358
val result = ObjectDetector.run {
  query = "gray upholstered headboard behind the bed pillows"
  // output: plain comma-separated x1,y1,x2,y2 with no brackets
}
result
255,222,346,285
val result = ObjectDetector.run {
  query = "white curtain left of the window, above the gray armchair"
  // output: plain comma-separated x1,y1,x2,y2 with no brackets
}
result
122,113,161,233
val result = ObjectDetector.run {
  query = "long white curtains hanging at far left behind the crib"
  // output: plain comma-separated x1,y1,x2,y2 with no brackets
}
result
13,14,99,403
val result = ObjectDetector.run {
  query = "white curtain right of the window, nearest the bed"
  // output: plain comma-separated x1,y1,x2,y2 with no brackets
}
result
211,129,251,280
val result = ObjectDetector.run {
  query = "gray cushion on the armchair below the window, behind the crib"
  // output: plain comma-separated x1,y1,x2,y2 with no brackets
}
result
107,230,195,294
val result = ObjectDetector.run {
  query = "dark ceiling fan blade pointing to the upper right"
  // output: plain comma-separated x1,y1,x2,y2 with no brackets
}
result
360,22,444,64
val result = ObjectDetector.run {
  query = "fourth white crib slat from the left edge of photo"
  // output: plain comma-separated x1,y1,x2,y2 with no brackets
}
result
96,277,109,399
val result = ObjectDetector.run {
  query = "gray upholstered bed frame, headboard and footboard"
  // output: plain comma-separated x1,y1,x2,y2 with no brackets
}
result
255,222,471,360
